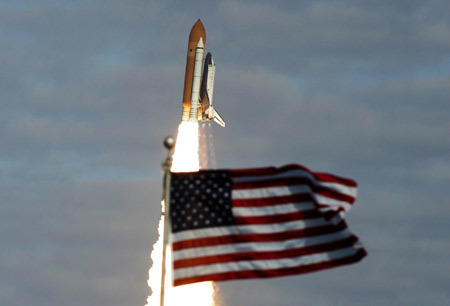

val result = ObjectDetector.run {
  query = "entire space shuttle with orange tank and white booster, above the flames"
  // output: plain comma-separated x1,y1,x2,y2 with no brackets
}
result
181,19,225,127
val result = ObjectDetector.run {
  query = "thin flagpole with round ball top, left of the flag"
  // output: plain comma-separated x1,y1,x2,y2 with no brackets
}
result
159,136,175,306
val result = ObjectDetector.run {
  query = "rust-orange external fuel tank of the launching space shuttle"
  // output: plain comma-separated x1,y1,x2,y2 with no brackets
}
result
182,19,206,121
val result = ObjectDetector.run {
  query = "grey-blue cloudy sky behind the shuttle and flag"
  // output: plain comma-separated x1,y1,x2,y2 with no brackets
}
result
0,0,450,306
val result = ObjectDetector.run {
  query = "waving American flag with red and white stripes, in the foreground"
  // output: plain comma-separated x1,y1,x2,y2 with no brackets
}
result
170,165,367,286
